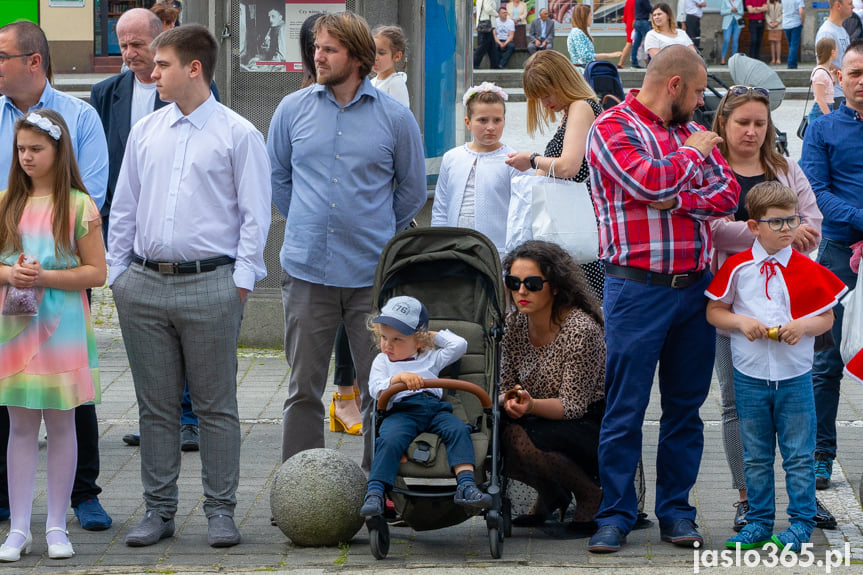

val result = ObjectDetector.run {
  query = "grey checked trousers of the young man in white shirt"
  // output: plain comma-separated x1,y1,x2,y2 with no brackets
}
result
113,263,243,519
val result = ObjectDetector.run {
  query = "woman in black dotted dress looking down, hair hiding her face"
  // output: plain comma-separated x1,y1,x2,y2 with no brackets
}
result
506,50,605,300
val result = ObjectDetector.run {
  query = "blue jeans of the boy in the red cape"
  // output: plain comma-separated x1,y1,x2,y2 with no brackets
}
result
734,369,815,533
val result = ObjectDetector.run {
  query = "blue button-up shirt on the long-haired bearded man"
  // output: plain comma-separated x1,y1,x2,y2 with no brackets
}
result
267,79,426,288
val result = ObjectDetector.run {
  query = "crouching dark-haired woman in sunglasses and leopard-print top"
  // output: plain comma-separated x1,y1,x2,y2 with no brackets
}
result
499,241,605,536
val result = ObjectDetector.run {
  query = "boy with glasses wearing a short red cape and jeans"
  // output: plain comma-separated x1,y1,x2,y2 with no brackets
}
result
705,181,848,552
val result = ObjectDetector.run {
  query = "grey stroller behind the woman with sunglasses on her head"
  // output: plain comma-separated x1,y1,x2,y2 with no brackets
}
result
692,53,788,156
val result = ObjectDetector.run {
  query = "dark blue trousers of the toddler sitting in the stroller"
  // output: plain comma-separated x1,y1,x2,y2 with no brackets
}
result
369,392,474,486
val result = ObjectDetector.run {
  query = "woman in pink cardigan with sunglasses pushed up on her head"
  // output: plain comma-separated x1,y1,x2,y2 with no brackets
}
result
711,86,827,531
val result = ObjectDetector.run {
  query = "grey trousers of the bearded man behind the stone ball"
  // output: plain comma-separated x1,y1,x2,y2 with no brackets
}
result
280,271,375,472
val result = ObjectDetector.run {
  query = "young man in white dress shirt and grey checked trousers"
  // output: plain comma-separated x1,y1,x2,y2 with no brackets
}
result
108,25,271,547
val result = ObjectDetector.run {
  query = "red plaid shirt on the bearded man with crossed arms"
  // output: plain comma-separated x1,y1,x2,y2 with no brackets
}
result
588,90,740,274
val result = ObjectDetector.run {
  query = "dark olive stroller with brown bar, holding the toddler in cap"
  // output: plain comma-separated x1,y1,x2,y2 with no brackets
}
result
366,227,512,559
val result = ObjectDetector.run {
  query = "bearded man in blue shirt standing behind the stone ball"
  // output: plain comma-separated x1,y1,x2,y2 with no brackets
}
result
267,12,426,469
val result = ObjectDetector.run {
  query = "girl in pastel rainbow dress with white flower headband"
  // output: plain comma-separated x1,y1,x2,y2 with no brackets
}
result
0,108,106,561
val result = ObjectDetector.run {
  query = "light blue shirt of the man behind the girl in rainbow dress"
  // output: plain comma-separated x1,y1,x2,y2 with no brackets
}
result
0,80,108,209
